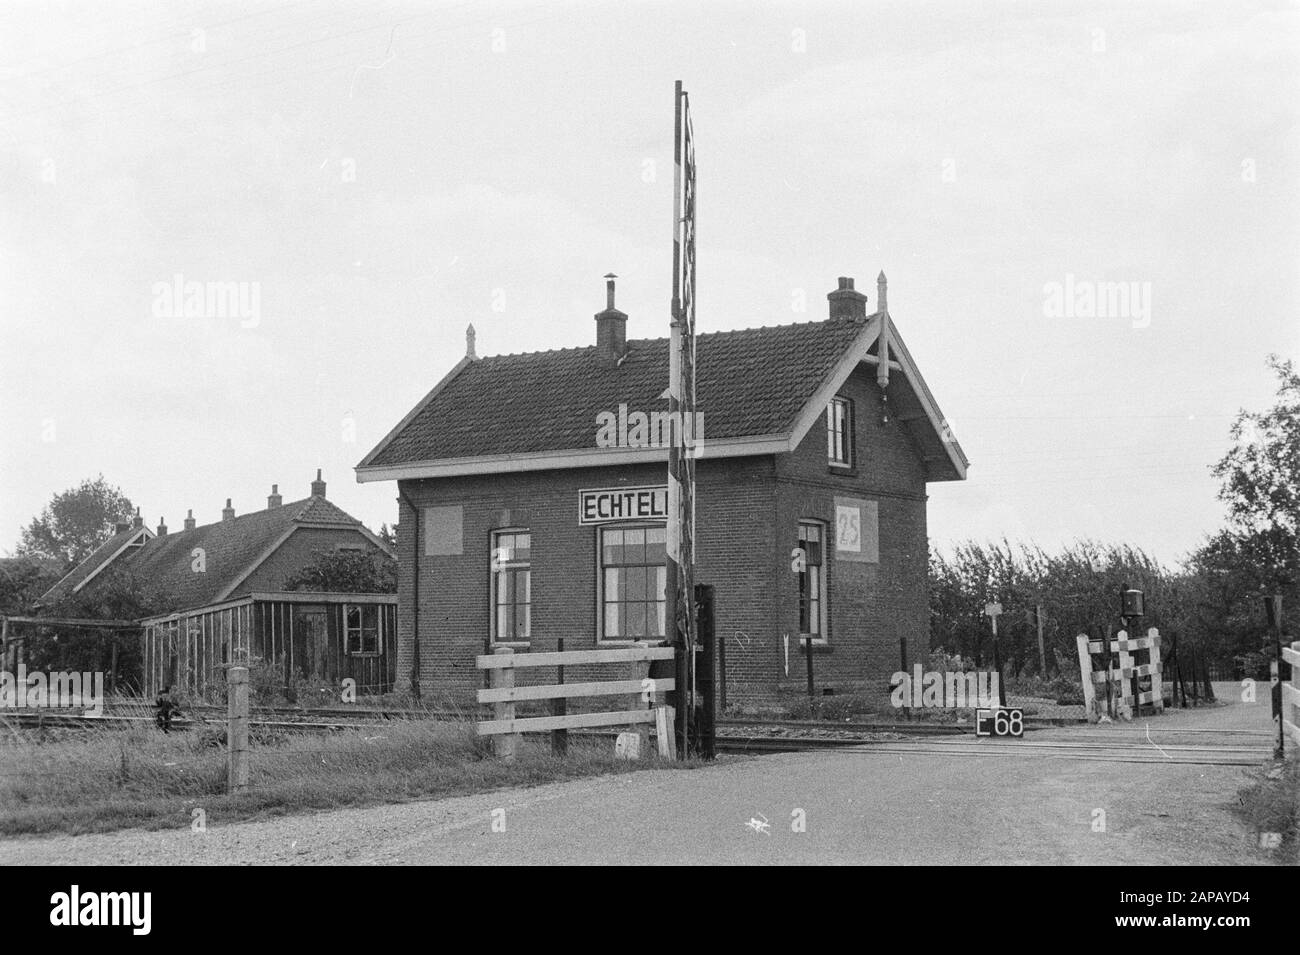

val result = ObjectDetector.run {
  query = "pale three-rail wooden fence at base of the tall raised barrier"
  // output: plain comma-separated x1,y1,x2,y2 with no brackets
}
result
476,643,676,759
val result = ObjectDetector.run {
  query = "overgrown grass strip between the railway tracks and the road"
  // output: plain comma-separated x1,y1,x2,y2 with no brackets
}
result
0,720,698,835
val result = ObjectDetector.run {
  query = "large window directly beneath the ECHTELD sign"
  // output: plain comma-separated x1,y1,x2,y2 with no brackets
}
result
601,526,668,641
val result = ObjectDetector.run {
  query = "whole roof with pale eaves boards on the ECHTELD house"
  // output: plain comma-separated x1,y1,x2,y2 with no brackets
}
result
356,294,969,481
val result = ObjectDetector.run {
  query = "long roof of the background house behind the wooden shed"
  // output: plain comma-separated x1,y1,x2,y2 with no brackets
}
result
42,495,387,612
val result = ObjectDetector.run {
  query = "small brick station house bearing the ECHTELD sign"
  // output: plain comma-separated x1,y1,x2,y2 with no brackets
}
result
358,274,967,700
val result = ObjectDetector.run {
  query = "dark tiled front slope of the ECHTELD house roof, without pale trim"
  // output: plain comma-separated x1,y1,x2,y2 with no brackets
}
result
367,320,863,466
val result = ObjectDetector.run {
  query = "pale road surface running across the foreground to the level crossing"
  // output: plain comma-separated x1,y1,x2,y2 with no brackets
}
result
0,685,1271,865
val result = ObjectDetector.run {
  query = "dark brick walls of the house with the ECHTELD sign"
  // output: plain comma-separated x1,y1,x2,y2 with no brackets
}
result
398,369,928,702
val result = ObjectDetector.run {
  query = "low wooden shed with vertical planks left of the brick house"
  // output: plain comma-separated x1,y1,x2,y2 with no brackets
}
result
140,591,398,696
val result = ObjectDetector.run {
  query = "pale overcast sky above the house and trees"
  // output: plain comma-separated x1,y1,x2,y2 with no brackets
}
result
0,0,1300,564
